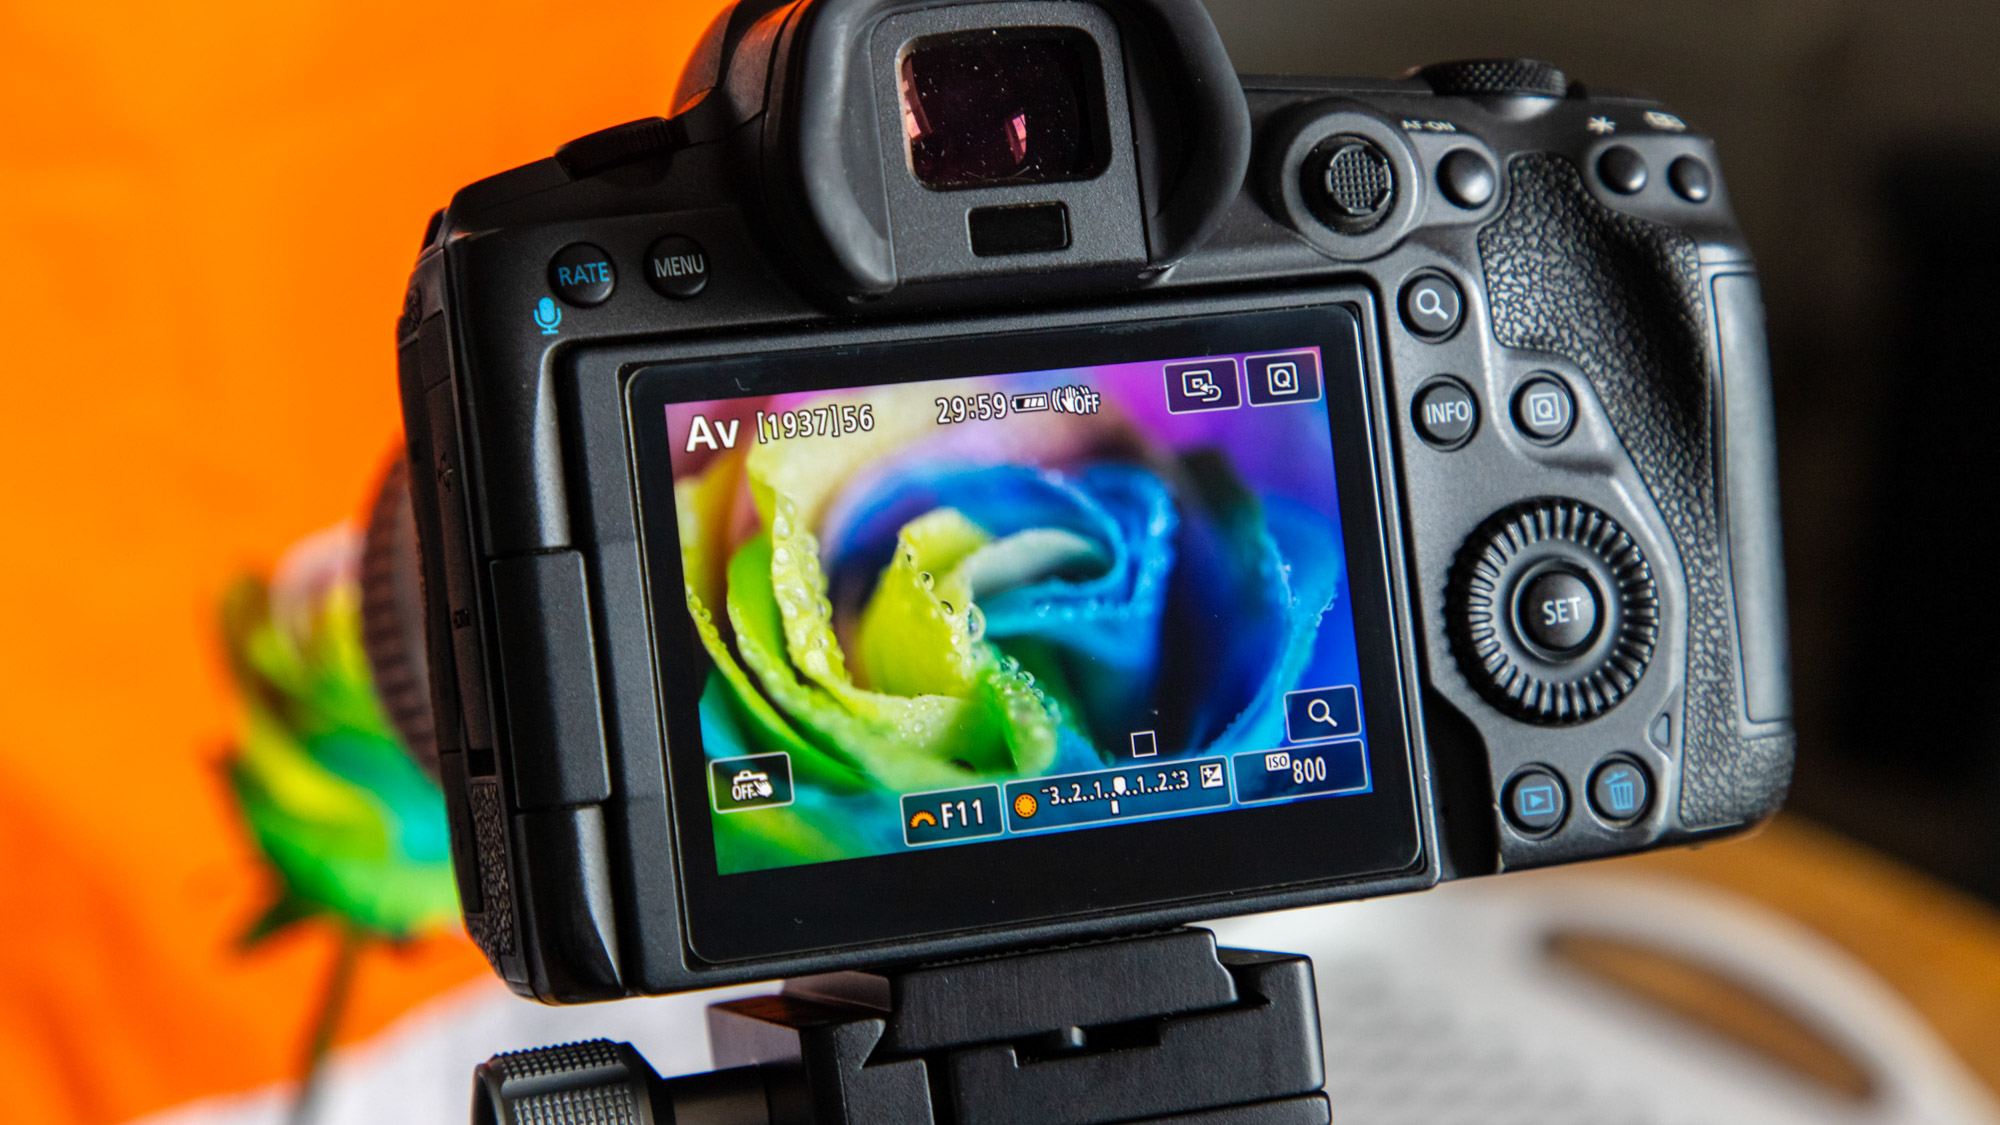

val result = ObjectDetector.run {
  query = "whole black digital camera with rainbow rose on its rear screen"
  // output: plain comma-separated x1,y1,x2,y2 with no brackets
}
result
370,0,1792,1003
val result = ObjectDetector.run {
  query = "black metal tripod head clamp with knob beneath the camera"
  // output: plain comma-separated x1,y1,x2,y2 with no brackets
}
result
472,929,1330,1125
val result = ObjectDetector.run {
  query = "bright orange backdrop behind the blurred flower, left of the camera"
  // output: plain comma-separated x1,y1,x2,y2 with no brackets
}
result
0,0,722,1123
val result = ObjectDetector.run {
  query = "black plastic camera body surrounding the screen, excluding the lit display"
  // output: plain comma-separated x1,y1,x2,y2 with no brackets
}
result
386,0,1792,1001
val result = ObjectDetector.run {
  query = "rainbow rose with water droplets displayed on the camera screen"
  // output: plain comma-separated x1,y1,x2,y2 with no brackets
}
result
668,378,1344,873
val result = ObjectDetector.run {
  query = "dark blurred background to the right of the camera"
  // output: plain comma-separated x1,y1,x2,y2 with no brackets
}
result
1208,0,2000,901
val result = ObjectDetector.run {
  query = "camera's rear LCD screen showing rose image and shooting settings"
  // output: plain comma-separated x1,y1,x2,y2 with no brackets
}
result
632,308,1414,949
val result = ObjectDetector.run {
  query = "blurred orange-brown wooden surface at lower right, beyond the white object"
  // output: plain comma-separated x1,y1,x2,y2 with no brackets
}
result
1578,817,2000,1091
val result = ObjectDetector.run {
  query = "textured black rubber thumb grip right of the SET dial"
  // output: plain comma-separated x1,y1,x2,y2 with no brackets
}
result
1480,154,1794,829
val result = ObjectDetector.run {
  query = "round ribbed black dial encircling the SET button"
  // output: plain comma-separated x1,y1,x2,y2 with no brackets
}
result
1446,498,1660,725
